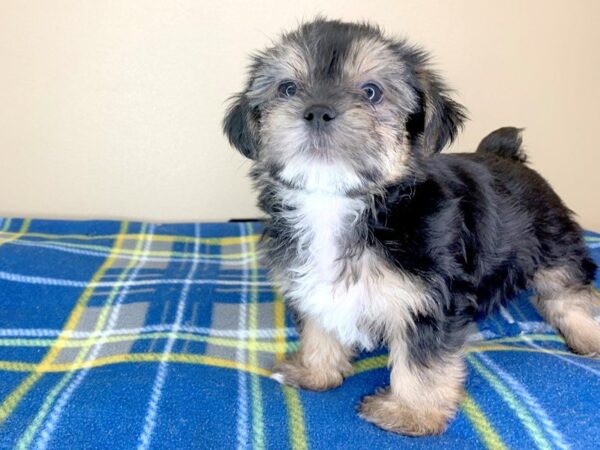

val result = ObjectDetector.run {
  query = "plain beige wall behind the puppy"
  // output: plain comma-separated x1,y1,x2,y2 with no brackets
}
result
0,0,600,230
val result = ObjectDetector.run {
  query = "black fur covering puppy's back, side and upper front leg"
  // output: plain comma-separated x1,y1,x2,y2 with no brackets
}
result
368,128,596,364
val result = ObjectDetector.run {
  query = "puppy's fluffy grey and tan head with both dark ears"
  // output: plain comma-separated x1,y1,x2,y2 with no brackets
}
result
224,20,465,193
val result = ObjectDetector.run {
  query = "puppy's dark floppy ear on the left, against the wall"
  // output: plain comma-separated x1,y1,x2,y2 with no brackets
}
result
223,94,258,159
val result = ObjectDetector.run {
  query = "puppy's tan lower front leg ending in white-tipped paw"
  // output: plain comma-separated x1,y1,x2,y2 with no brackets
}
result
271,319,352,391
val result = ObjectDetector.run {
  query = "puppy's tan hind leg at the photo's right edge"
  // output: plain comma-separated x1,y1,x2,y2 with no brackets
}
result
534,268,600,357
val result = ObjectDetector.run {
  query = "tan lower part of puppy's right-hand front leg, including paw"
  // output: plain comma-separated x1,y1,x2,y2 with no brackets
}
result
359,338,465,436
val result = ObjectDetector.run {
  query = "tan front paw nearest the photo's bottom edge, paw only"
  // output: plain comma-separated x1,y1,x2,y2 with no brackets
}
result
358,389,451,436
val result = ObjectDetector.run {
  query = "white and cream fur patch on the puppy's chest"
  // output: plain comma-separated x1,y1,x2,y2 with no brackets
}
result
279,188,426,349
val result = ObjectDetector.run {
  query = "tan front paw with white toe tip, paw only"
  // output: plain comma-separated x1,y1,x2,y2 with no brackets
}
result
271,359,352,391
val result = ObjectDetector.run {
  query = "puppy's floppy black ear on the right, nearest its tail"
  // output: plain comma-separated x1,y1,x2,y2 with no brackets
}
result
406,67,467,154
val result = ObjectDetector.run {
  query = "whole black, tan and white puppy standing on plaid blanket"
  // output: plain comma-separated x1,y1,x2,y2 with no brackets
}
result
224,19,600,435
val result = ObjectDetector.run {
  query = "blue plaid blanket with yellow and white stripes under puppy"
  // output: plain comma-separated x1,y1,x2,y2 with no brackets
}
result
0,219,600,449
